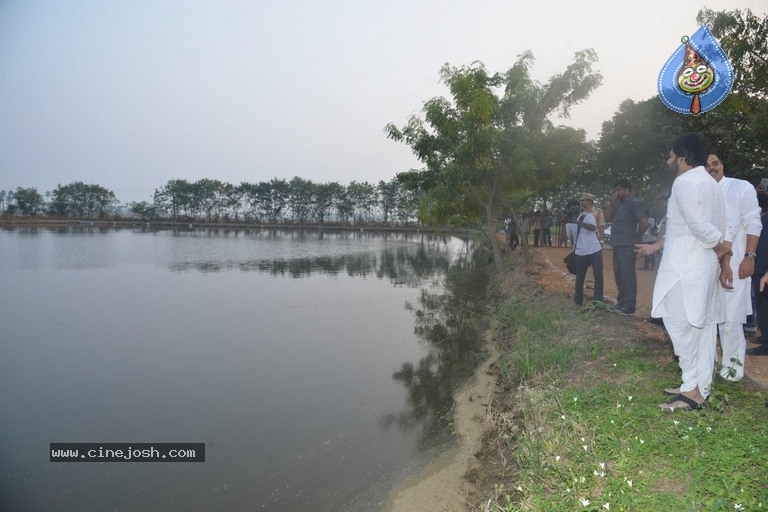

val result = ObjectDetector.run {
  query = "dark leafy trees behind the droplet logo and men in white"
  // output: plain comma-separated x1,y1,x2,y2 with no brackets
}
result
596,9,768,196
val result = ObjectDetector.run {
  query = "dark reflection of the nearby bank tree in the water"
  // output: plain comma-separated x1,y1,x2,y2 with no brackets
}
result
382,253,488,449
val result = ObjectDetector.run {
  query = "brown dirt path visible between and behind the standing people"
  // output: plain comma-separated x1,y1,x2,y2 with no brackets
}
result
529,246,768,388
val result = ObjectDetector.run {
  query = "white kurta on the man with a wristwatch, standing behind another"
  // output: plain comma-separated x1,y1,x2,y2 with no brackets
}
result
719,177,763,324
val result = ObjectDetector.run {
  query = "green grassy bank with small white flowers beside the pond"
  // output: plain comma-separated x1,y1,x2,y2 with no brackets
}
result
475,260,768,512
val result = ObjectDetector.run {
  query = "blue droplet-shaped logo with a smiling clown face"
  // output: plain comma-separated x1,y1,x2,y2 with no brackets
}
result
658,25,733,115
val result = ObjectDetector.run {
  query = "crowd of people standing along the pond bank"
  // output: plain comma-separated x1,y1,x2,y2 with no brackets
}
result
508,133,768,410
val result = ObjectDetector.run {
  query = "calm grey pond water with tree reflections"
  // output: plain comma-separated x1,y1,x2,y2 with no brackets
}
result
0,228,486,512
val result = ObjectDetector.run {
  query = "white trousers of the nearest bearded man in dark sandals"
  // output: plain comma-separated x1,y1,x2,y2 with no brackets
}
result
662,283,717,398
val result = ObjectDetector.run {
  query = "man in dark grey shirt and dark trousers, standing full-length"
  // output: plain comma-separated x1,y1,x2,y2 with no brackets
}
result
605,180,648,315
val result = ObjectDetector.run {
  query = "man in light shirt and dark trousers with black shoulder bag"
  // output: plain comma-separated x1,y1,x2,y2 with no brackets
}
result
566,203,603,306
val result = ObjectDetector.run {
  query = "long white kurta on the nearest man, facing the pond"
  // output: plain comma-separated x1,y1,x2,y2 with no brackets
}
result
651,166,733,328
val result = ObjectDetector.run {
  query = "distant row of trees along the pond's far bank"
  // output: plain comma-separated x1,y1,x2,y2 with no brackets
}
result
0,177,418,225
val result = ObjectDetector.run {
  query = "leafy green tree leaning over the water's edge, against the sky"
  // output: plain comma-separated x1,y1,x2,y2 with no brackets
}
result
386,50,602,271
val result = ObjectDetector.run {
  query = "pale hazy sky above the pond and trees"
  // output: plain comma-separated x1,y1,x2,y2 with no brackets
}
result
0,0,768,203
